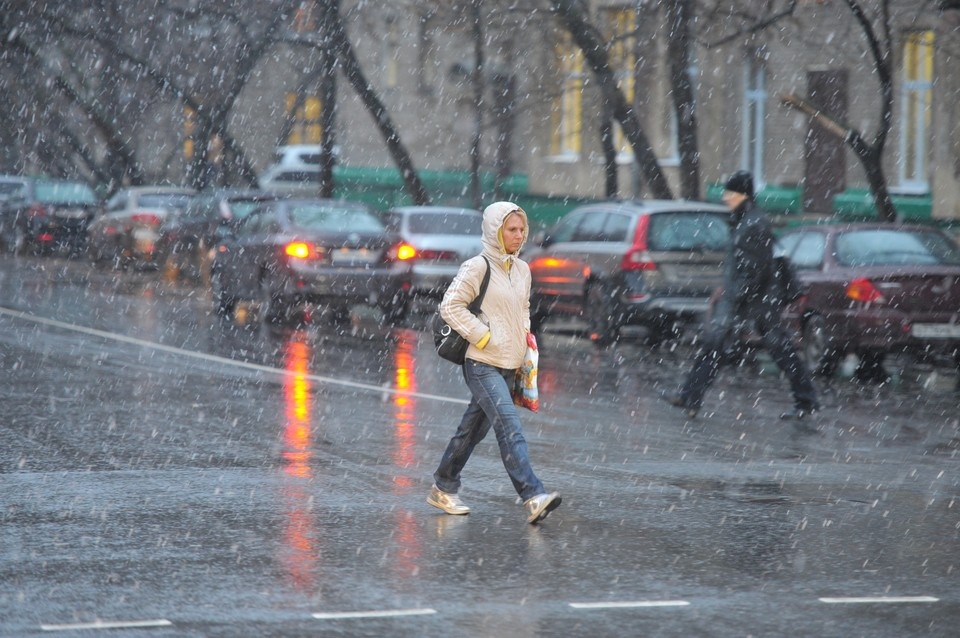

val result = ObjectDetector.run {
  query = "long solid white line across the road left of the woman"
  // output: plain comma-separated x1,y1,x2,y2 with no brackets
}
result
0,307,469,405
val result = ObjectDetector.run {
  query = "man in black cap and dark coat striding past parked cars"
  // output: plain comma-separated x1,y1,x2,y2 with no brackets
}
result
664,171,820,419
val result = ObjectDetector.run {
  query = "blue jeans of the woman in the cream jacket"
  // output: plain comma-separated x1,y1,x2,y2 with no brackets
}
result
433,359,546,500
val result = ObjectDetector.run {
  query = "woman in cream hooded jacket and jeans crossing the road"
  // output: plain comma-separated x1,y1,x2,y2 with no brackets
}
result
427,202,561,523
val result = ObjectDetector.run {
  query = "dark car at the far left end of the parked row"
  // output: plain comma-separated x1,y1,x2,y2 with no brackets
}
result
2,178,100,254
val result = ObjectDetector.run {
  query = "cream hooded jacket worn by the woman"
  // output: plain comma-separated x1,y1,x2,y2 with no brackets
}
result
440,202,530,369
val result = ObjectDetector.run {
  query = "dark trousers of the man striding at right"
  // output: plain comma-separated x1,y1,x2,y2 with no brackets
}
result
680,313,819,410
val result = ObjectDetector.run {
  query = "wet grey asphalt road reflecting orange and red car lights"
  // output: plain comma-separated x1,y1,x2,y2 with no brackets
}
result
0,255,960,637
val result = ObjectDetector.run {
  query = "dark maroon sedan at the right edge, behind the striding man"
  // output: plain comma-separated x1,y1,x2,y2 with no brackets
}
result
779,224,960,375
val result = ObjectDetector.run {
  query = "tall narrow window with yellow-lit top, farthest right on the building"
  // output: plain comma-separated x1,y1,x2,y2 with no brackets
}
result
898,31,933,192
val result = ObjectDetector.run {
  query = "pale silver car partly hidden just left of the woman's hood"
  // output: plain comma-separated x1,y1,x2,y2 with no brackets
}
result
383,206,483,299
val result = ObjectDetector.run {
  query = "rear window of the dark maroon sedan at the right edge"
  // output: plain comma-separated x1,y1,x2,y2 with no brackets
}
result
835,230,960,267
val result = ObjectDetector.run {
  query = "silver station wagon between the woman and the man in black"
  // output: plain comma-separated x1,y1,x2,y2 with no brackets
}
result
524,200,730,346
